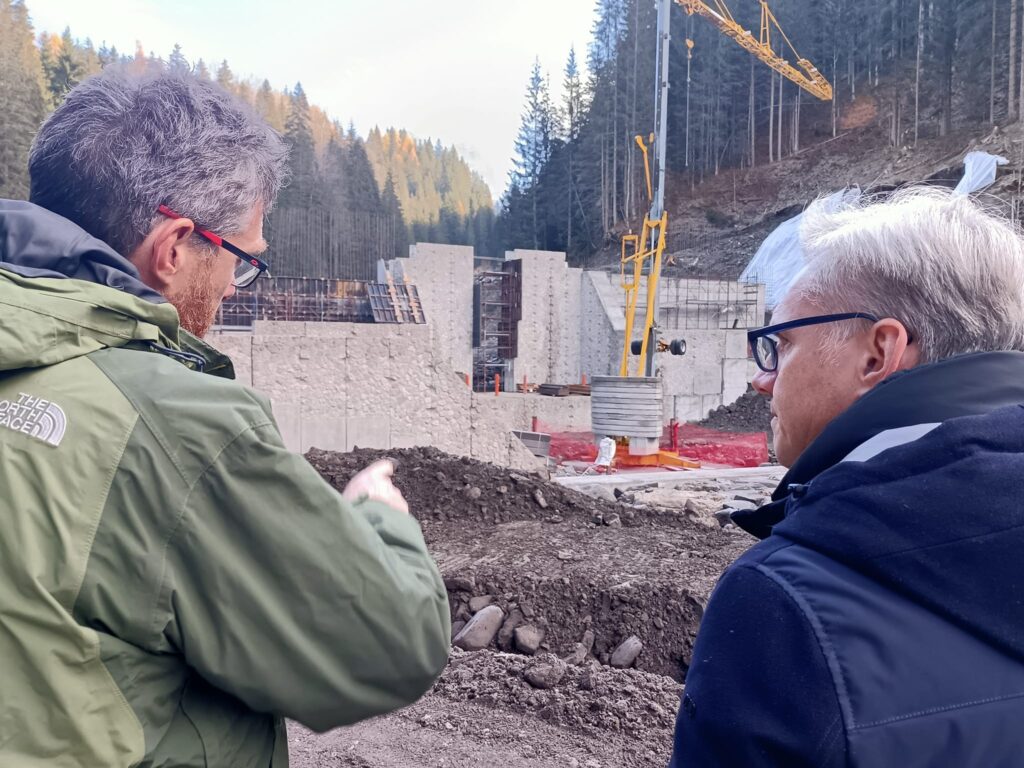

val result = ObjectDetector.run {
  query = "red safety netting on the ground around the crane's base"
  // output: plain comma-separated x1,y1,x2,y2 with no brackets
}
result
532,421,768,467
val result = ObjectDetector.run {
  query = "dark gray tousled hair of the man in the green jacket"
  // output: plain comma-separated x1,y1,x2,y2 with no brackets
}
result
29,67,288,255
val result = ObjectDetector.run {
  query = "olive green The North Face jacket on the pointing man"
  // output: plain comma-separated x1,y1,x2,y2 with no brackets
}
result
0,201,450,768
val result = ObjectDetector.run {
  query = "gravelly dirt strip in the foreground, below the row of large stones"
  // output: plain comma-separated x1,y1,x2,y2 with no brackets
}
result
288,650,680,768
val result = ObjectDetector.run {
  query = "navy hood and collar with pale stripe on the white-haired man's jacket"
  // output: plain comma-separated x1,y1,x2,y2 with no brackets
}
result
755,352,1024,659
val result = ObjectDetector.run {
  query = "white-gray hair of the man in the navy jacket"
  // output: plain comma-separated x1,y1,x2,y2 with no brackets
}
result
794,187,1024,362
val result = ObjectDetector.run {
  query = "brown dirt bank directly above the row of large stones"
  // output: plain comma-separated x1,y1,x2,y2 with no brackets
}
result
432,520,753,680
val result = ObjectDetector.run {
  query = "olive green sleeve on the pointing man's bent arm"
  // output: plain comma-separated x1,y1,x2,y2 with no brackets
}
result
159,423,451,730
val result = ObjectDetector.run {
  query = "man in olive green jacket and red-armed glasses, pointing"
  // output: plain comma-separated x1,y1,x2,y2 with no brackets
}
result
0,70,450,768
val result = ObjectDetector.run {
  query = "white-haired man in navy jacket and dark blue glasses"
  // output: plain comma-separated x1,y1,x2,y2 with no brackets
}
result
672,189,1024,768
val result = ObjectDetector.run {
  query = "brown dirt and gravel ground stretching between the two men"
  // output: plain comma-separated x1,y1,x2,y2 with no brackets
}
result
290,449,781,768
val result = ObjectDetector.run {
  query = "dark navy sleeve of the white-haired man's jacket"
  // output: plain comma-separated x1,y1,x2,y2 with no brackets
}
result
670,565,846,768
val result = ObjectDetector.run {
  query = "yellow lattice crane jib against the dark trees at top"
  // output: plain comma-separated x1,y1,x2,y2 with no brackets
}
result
675,0,833,101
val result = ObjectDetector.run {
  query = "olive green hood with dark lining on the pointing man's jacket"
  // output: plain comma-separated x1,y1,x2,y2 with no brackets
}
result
0,200,230,373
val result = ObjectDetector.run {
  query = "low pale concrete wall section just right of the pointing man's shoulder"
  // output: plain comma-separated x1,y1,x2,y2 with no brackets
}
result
208,322,590,469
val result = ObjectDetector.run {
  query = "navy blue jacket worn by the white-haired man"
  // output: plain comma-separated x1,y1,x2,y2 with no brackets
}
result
671,352,1024,768
